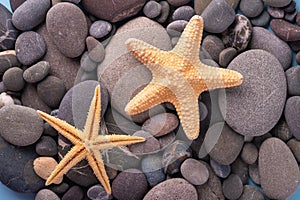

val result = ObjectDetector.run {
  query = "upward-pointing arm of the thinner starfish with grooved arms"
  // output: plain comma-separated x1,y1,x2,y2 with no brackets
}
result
83,85,101,140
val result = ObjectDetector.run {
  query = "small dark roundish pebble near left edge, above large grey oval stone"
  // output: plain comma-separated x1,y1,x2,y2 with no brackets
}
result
3,67,25,92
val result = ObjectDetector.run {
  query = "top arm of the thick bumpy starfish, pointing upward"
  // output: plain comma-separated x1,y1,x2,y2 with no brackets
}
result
172,15,204,63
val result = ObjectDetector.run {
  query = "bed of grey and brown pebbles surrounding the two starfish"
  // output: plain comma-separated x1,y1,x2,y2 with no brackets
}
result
0,0,300,200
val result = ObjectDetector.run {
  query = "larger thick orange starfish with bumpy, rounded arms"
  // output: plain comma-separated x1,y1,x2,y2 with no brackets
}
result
125,15,243,140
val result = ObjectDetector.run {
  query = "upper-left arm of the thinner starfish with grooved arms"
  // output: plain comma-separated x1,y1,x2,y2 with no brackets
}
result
37,110,81,144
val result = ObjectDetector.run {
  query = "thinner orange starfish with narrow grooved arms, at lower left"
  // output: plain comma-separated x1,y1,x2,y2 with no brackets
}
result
37,85,145,194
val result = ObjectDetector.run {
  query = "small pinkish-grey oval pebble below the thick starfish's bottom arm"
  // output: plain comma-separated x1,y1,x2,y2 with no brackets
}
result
180,158,209,185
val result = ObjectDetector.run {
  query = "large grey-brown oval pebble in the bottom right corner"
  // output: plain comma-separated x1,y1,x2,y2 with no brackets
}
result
258,138,300,199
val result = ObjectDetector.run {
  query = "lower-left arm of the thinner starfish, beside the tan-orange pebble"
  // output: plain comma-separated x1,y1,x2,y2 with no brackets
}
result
45,145,87,186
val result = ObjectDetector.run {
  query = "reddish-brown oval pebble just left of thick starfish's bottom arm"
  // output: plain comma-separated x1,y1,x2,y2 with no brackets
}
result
142,113,179,137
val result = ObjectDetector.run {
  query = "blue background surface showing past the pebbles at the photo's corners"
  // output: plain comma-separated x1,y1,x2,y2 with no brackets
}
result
0,0,300,200
